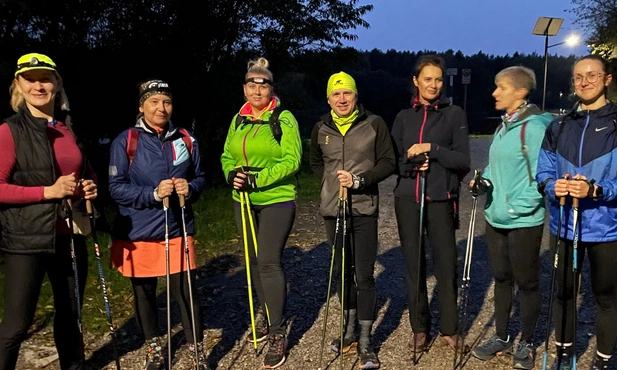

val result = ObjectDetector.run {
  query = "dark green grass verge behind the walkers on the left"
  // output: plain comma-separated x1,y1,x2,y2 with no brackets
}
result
0,170,320,334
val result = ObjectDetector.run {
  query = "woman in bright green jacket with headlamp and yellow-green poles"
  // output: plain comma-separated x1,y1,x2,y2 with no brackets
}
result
221,58,302,369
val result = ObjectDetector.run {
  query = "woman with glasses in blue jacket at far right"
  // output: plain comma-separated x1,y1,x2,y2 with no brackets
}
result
536,55,617,370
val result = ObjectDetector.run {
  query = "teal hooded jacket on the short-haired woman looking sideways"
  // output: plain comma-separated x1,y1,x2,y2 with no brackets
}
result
482,106,553,229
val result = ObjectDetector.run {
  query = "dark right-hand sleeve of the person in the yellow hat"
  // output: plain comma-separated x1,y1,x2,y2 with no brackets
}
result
358,116,396,186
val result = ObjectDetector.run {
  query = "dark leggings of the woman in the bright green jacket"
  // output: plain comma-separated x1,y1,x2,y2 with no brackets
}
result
235,204,296,334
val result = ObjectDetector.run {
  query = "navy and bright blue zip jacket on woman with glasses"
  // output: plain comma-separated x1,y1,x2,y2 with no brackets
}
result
536,102,617,242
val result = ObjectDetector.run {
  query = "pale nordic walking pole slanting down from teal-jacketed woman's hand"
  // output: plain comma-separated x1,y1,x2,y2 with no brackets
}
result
453,170,481,369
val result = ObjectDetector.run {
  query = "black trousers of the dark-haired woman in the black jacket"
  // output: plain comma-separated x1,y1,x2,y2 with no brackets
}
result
394,197,458,335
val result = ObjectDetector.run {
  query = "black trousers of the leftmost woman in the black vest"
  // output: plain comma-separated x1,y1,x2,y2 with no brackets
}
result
0,235,88,370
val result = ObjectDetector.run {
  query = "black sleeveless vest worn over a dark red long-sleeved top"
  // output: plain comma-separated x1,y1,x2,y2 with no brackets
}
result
0,109,61,254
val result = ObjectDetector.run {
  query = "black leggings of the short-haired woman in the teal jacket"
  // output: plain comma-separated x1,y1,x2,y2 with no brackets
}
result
485,222,544,343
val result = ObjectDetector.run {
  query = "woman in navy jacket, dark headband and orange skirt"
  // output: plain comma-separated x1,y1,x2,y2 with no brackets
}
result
109,80,205,370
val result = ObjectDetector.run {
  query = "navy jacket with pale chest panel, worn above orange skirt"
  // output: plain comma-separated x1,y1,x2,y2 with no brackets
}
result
109,119,205,241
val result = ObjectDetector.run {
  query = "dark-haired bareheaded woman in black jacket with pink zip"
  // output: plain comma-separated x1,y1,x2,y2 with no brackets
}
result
392,55,470,351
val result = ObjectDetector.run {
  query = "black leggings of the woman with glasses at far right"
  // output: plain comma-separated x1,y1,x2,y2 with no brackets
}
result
551,235,617,355
